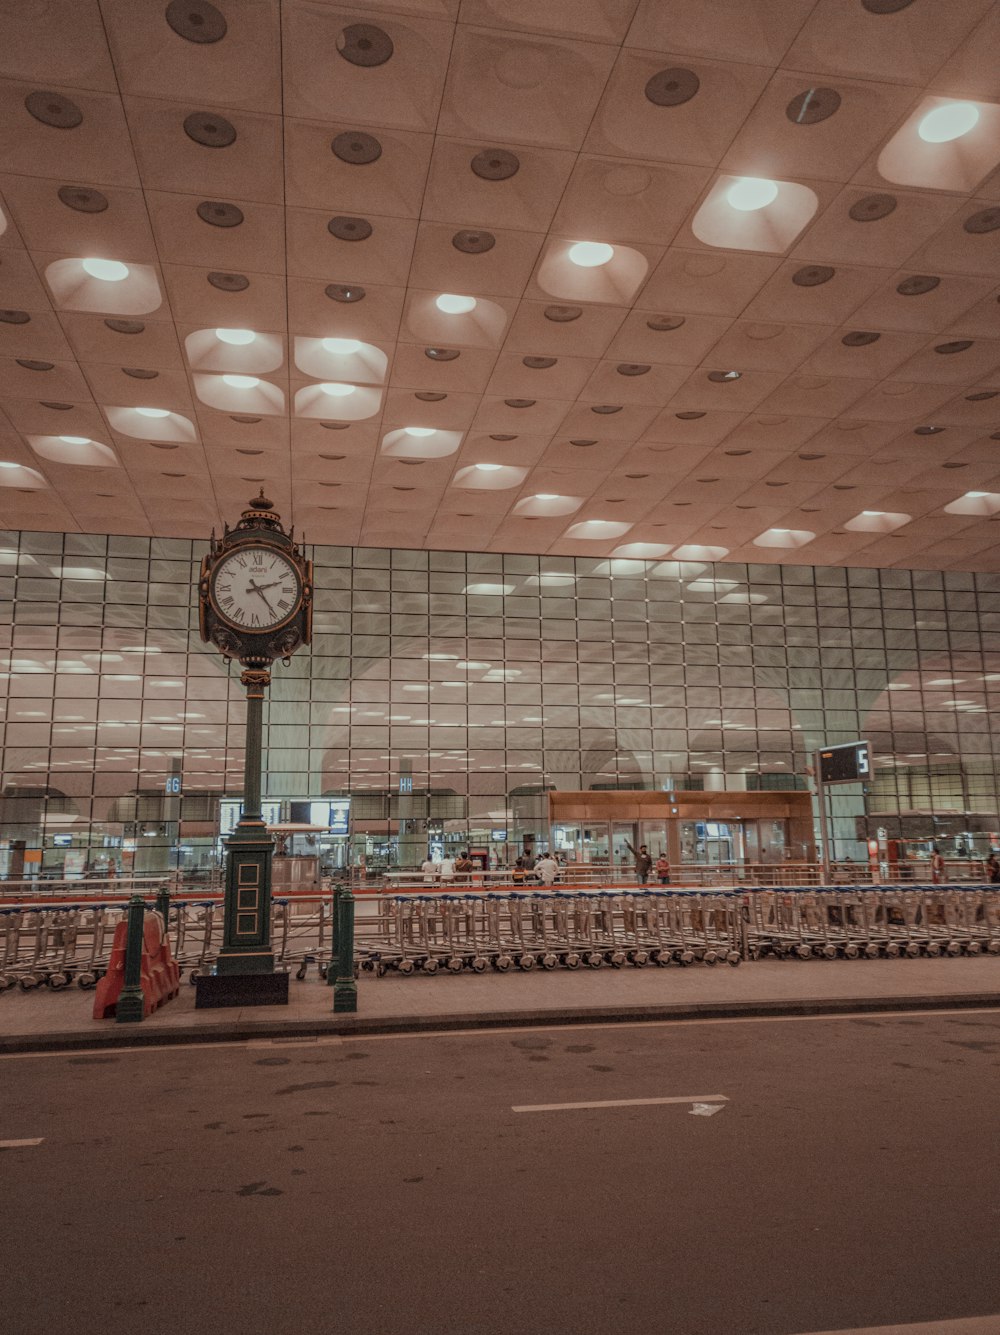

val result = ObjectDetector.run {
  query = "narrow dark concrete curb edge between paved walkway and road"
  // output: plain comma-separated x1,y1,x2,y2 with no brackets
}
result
0,992,1000,1055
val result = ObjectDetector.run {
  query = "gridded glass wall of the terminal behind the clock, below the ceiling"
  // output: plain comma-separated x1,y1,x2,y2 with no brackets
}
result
0,533,1000,869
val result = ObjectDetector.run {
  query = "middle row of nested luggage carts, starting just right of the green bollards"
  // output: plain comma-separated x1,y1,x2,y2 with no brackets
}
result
356,890,742,976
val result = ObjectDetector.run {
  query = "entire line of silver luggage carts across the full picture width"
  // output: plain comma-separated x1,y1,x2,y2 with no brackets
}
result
0,884,1000,991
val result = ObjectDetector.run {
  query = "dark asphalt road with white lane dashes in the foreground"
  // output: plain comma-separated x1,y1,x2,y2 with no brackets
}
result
0,1012,1000,1335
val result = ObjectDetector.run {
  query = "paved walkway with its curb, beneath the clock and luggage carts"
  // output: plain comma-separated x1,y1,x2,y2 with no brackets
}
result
0,956,1000,1052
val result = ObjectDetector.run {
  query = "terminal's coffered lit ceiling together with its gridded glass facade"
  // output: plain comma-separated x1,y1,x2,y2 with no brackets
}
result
0,0,1000,880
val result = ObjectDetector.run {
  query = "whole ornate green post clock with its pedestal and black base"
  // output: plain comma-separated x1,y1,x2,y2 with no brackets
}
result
198,490,312,1007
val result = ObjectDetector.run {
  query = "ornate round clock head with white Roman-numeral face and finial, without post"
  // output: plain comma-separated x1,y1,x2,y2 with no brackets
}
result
199,487,312,672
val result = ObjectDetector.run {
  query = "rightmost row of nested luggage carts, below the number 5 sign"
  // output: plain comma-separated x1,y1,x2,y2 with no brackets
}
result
742,885,1000,960
